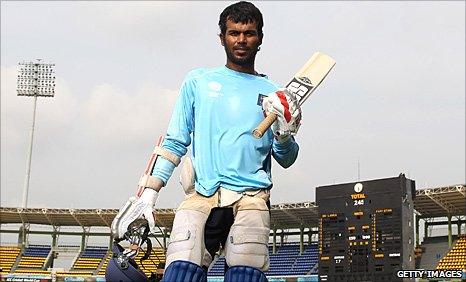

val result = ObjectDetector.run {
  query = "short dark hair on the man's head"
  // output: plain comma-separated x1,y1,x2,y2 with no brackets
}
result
218,1,264,37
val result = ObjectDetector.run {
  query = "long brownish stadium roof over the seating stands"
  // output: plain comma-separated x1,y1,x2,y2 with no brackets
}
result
0,184,466,229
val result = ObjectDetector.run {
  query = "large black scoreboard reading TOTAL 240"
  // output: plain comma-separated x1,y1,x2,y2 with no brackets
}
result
316,174,415,281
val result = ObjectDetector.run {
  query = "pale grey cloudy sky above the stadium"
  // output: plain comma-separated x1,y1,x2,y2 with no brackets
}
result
0,1,466,208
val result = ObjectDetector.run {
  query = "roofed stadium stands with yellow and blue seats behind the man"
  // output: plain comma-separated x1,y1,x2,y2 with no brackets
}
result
0,184,466,281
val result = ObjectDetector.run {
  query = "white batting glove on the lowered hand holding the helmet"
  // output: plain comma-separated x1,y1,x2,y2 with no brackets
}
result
111,188,159,239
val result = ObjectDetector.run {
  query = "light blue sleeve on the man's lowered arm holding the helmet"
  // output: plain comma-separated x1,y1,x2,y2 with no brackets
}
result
152,71,196,185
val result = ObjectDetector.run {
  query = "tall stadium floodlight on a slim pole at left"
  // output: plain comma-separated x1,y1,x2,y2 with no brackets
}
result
17,59,55,208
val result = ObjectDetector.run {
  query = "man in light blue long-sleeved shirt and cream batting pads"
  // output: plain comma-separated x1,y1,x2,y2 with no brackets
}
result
112,1,301,281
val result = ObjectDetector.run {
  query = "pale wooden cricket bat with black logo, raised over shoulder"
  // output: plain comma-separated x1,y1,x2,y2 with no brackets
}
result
252,52,335,138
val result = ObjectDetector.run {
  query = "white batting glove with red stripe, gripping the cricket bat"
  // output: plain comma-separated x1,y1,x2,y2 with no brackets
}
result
262,89,301,141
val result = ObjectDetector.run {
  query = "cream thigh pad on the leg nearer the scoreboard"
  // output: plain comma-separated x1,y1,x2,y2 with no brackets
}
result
225,210,270,271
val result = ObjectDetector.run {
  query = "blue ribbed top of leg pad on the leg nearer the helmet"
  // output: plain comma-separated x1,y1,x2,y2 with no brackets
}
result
162,260,207,282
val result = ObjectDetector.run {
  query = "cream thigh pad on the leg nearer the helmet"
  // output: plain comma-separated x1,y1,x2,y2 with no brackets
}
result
165,210,210,267
